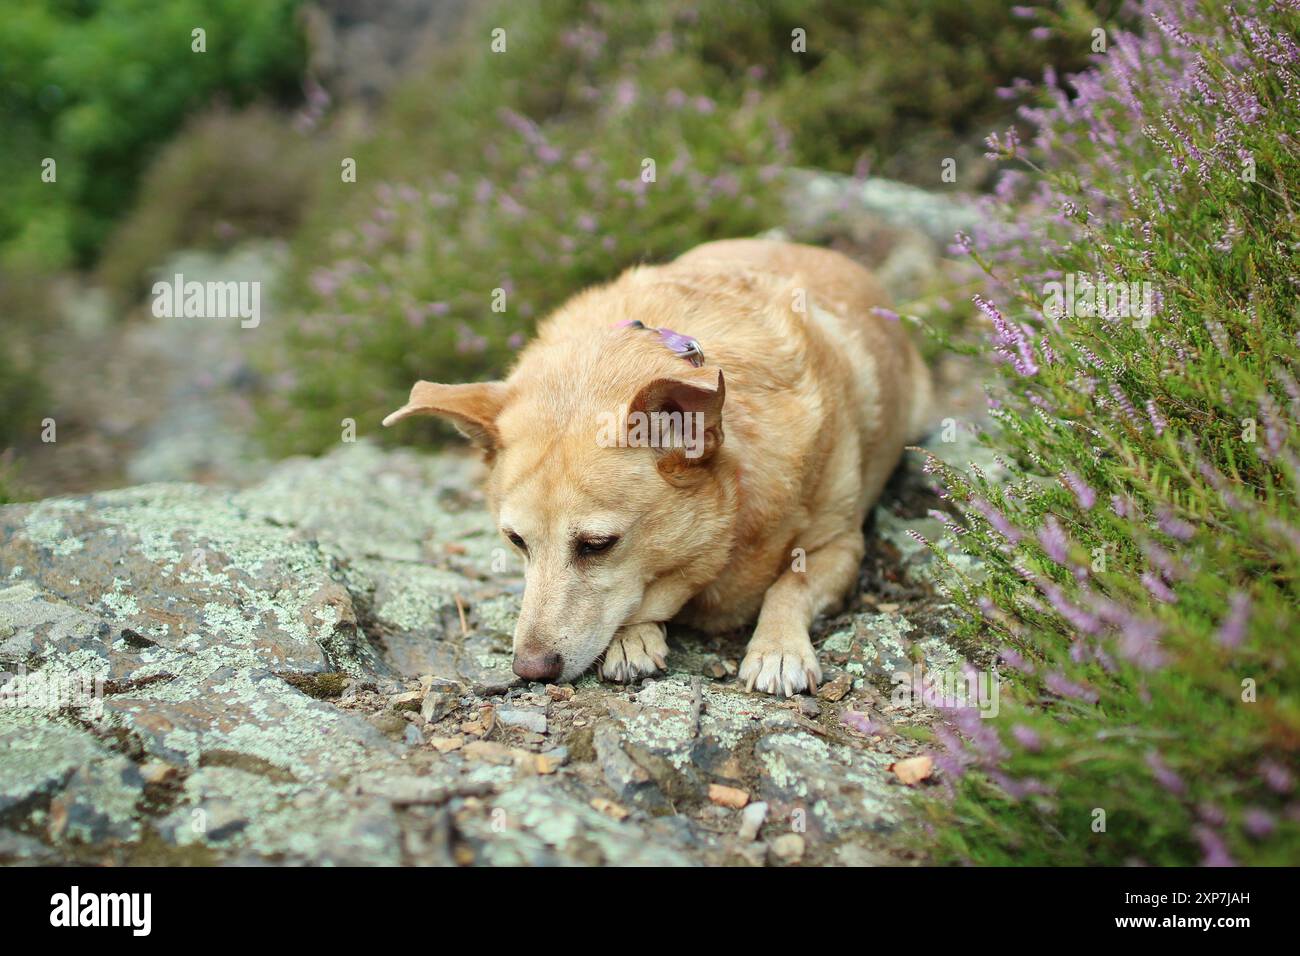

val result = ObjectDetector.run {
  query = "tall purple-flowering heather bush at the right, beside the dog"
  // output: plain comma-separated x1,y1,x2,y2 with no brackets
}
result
927,0,1300,864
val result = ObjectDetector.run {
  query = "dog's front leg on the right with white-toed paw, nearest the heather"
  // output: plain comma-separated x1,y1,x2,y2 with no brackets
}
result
740,531,866,697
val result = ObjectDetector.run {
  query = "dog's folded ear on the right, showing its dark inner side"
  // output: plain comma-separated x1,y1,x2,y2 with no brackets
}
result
628,368,727,484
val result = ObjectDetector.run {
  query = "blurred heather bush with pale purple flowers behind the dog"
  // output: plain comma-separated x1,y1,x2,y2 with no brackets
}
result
264,0,1095,451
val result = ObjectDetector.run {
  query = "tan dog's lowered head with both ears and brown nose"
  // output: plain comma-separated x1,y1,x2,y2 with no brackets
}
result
384,359,733,682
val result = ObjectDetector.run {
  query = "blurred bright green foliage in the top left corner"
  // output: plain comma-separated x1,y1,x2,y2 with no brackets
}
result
0,0,306,269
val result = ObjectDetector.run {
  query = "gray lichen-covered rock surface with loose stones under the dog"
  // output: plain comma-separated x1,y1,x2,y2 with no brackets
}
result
0,442,977,865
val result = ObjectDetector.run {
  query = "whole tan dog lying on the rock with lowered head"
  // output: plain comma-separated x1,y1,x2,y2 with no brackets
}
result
384,239,931,697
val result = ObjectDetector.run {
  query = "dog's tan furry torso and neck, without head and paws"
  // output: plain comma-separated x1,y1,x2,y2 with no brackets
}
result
519,239,930,630
